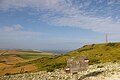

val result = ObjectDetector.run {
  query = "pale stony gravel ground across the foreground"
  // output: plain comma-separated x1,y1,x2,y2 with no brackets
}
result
0,62,120,80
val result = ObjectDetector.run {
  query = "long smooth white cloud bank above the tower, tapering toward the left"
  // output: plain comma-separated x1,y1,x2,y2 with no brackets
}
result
48,15,120,33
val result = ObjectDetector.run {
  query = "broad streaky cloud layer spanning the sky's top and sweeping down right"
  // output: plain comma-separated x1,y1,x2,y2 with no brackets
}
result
0,0,120,33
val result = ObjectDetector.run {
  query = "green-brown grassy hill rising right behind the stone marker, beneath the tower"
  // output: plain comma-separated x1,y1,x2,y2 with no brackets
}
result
16,42,120,71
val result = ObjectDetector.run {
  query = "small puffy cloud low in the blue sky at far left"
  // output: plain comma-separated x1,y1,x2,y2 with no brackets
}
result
2,24,23,32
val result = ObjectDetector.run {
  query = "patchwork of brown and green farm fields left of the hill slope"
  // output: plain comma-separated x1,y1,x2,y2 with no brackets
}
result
0,50,53,75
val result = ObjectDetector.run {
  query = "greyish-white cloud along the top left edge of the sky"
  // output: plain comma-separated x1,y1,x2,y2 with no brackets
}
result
0,0,64,10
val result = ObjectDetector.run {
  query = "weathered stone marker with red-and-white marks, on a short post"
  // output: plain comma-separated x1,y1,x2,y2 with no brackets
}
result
65,56,89,80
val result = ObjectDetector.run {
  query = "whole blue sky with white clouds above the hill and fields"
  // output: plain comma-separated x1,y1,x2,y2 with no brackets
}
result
0,0,120,50
